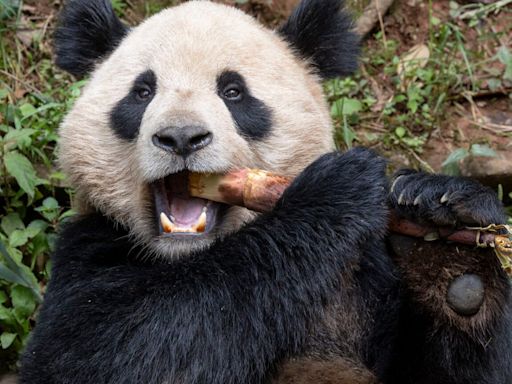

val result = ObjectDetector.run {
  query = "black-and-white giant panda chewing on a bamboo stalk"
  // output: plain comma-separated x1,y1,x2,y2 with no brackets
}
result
21,0,512,384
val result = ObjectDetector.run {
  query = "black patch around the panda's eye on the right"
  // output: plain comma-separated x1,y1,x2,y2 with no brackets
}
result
217,71,272,140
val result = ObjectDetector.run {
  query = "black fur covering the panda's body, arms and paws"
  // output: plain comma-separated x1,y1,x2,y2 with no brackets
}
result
21,149,512,384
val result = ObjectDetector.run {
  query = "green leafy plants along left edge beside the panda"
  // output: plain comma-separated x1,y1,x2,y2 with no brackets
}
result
0,7,84,374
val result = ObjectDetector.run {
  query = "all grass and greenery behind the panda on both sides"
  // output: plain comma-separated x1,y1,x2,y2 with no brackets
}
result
0,0,512,373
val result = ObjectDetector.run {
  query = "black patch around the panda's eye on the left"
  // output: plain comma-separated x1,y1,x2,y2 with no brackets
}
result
110,70,156,140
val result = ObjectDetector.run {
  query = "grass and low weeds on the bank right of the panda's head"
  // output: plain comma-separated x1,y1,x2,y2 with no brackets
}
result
326,2,512,173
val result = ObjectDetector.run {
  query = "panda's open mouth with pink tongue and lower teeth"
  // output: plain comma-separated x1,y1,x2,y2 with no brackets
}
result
152,171,225,236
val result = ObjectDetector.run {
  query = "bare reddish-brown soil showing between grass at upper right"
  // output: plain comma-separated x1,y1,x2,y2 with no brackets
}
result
366,0,512,182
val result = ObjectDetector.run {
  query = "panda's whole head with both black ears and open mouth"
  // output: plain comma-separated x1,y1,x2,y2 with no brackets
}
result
55,0,358,257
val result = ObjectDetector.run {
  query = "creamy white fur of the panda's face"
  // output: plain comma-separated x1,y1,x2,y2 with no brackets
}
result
60,1,334,257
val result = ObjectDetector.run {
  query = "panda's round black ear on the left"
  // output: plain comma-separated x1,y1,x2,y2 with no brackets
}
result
54,0,128,76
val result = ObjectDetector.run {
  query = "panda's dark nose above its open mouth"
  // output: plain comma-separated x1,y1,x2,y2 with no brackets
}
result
153,126,213,156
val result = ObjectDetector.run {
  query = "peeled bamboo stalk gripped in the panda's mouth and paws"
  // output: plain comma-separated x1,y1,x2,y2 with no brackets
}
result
189,169,512,249
